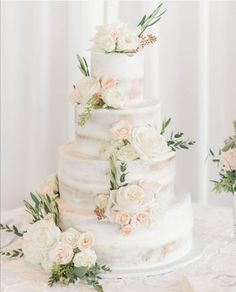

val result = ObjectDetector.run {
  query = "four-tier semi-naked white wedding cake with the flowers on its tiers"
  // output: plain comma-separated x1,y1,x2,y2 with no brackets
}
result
58,5,193,271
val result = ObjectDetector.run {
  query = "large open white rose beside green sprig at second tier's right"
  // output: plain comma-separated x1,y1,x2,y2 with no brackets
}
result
130,126,168,160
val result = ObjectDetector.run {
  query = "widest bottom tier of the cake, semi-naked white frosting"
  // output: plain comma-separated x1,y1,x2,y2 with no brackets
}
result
61,189,193,271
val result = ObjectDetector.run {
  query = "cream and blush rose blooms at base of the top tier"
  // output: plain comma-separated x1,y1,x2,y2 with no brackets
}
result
70,75,129,109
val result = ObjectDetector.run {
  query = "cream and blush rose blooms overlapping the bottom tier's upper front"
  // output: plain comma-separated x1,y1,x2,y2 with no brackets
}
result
96,181,167,236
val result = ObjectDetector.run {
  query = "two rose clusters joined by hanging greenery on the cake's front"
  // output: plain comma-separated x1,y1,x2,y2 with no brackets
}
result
94,118,195,236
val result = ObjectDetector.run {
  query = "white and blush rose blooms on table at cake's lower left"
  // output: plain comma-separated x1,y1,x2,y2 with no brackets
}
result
22,217,97,273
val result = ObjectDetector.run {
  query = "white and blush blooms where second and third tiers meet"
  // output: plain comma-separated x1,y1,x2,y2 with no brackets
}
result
100,120,169,161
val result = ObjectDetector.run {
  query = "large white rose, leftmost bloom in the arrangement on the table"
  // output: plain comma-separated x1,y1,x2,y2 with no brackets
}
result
24,220,61,251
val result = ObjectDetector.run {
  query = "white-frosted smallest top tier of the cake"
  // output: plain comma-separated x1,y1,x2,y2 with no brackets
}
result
91,51,144,105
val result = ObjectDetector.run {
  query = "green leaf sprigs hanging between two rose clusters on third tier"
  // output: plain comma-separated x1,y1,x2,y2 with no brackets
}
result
109,156,128,191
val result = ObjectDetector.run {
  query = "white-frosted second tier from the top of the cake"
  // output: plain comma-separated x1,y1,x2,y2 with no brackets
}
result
75,101,161,156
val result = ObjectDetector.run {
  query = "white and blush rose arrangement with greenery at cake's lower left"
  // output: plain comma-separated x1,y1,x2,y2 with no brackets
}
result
0,175,110,292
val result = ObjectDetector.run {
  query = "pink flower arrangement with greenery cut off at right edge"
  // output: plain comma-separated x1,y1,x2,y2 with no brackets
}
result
210,121,236,237
